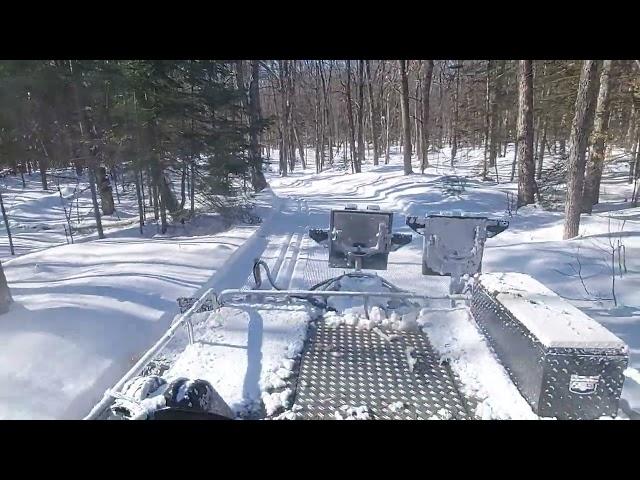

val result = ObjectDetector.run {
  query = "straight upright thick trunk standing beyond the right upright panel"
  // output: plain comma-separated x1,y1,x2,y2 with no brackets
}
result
518,60,537,207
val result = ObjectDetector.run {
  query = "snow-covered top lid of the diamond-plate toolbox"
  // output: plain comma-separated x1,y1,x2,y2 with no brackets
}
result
479,272,627,353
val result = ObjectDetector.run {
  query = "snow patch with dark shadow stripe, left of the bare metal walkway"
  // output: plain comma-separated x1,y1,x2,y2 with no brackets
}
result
164,304,309,415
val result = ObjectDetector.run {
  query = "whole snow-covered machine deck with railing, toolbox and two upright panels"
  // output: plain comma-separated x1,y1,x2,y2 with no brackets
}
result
87,206,628,419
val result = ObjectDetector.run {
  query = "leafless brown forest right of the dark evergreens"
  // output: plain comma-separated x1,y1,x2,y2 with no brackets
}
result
260,60,640,238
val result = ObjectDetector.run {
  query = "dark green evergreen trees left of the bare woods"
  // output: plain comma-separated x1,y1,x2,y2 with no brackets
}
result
0,60,266,238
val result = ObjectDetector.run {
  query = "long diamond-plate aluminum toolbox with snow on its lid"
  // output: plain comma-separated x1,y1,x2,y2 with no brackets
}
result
471,273,629,419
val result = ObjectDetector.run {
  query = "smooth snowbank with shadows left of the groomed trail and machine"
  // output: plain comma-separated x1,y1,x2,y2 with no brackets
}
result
0,191,277,418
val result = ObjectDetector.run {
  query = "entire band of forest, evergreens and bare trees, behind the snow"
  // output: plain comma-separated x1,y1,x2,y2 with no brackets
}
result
0,60,640,242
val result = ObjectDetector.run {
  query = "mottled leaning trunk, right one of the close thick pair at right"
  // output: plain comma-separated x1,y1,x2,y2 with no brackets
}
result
582,60,611,213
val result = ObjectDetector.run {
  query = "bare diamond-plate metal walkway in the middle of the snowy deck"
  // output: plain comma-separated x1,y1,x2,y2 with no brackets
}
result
292,320,470,420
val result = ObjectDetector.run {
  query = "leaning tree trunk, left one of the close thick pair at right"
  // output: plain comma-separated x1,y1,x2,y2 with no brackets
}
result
563,60,598,240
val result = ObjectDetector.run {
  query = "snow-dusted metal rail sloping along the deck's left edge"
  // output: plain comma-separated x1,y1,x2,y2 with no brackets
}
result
84,288,217,420
